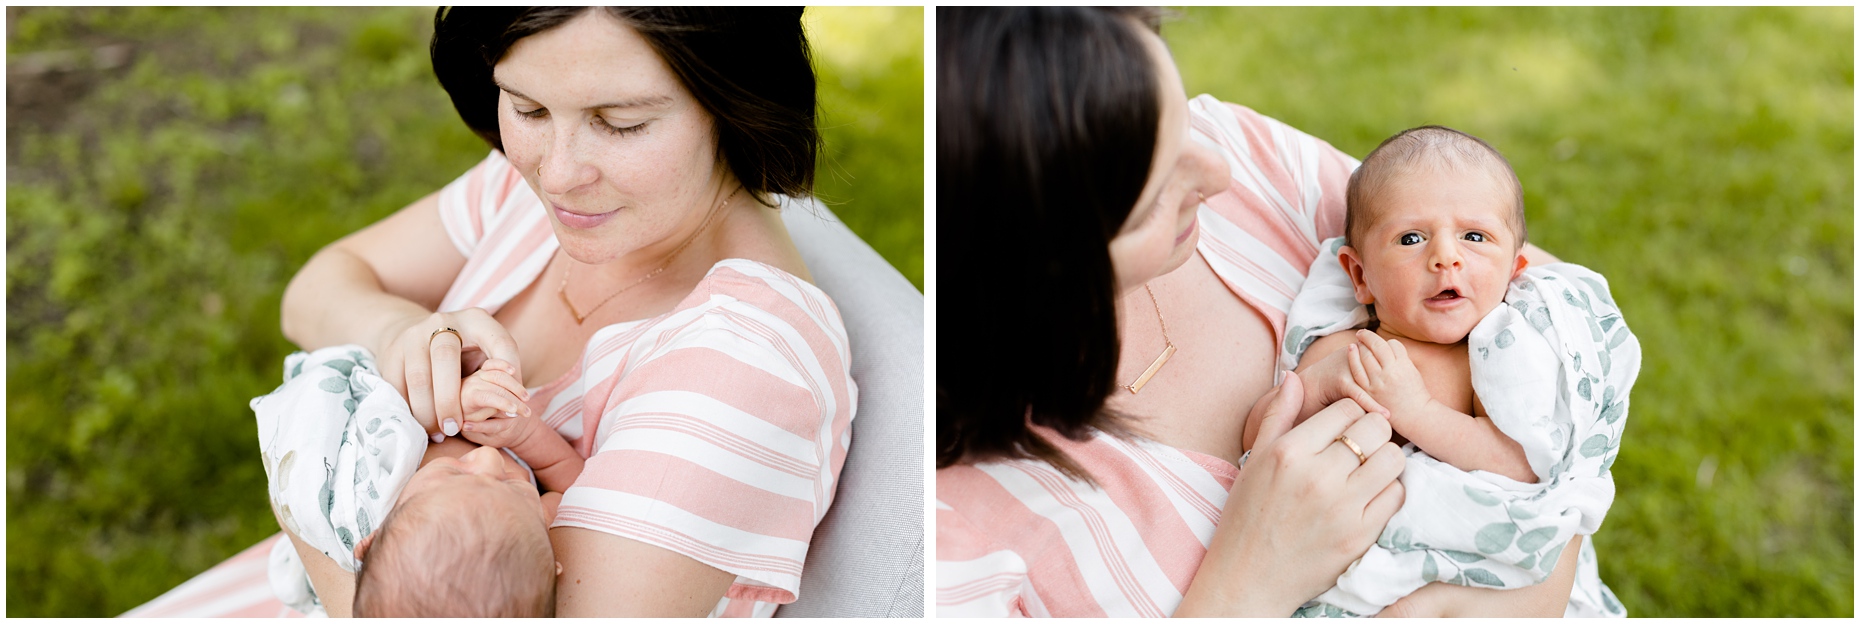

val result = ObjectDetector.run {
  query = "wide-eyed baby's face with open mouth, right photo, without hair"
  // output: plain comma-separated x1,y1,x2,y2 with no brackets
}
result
1339,170,1525,345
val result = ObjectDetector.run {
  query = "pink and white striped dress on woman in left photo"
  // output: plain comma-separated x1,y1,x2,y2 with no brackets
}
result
128,151,857,617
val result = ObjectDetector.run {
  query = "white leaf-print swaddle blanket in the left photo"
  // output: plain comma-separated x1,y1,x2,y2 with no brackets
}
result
251,345,426,615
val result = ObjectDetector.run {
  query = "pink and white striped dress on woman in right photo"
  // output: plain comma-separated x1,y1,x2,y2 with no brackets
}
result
936,95,1358,617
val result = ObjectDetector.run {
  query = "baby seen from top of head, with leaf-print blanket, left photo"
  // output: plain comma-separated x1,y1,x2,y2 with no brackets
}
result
253,346,582,617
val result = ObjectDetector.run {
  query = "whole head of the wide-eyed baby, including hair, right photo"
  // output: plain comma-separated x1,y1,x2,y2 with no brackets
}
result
1339,125,1525,345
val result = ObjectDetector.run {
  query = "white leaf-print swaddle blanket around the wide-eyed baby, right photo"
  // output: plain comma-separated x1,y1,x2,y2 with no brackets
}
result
1278,237,1641,617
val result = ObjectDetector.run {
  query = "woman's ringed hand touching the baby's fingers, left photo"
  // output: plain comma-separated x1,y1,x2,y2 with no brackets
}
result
376,307,528,436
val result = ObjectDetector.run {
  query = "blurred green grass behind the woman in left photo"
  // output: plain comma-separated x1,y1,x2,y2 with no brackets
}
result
6,7,924,617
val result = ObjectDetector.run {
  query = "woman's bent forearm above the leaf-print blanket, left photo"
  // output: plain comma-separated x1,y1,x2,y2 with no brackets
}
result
279,246,432,354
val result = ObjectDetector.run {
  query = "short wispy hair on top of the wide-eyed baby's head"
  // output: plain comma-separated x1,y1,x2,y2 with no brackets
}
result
1343,125,1525,248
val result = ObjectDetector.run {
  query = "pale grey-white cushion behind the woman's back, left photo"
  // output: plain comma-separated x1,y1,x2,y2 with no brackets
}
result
776,199,926,618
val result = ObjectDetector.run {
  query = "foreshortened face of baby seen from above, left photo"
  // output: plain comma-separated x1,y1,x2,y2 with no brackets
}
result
394,447,549,529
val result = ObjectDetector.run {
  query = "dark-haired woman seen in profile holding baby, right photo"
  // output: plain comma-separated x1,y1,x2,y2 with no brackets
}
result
936,7,1577,617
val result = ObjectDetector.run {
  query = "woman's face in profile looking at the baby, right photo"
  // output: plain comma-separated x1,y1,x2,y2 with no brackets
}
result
1110,26,1229,291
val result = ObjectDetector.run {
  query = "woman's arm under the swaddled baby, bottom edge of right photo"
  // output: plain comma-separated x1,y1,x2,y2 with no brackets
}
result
1376,535,1583,618
